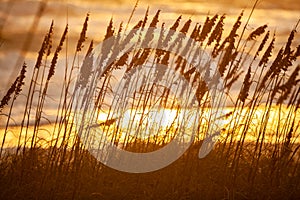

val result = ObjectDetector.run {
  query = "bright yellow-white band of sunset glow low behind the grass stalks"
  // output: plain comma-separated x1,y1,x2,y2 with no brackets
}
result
0,106,300,148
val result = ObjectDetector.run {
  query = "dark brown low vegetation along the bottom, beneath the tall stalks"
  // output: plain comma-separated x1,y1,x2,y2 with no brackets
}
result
0,141,300,199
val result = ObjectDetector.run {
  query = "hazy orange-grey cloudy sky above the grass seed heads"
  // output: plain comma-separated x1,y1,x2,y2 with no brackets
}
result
0,0,300,123
